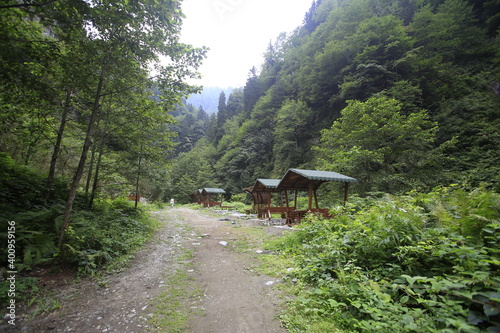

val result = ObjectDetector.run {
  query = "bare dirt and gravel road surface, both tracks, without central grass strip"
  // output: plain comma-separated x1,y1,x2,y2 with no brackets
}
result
0,207,292,333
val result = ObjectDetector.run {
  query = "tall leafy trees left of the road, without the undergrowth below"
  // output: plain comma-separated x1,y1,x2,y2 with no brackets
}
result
0,0,205,202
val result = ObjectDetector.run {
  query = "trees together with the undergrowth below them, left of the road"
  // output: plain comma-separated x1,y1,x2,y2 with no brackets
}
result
0,0,205,286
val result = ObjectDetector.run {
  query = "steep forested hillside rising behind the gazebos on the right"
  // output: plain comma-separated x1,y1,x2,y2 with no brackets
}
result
171,0,500,202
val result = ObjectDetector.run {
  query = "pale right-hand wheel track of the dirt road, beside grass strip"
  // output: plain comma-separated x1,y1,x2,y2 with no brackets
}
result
180,209,285,333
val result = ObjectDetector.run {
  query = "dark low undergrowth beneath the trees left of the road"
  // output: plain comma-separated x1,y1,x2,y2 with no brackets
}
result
0,155,158,306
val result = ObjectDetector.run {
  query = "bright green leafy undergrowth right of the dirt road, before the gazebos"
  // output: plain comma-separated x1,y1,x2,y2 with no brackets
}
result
264,188,500,333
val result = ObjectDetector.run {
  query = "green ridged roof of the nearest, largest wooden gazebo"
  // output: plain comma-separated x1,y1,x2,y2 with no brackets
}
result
277,169,358,190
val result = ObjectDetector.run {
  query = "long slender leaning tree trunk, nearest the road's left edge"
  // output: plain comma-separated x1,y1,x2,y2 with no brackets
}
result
58,63,107,248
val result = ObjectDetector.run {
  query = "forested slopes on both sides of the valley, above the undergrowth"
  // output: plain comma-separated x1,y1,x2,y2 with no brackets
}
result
0,0,500,206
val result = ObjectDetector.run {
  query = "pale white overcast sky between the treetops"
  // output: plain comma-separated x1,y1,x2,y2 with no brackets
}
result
181,0,312,88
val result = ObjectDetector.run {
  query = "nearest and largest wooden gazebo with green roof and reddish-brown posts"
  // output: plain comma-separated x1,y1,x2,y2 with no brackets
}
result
277,169,358,223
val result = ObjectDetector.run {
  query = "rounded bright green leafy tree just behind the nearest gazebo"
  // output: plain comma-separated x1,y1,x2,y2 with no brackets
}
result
315,97,439,192
